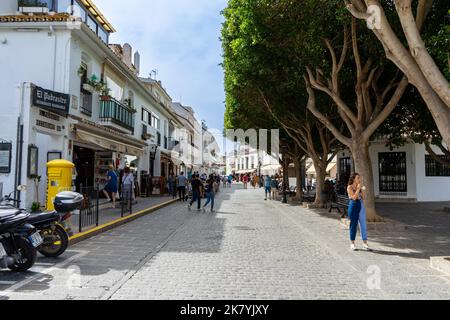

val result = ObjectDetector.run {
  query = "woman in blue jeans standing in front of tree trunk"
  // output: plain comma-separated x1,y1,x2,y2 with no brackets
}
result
347,173,370,251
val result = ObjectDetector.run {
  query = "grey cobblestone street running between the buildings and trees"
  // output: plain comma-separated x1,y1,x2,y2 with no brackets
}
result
0,186,450,300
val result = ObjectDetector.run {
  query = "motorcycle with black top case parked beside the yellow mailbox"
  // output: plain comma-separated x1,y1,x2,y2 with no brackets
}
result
0,192,83,258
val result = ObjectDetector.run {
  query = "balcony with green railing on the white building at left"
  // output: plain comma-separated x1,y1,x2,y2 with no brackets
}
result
100,97,136,134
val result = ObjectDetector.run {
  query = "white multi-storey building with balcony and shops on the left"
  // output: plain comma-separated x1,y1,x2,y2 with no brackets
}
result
0,0,182,207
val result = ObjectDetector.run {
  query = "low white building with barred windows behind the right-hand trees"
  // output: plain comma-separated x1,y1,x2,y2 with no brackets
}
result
337,141,450,202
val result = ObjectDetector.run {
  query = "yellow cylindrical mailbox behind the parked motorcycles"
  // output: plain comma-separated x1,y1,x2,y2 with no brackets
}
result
47,160,75,210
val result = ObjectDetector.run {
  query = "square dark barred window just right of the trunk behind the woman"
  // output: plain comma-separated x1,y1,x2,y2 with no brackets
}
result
378,152,408,192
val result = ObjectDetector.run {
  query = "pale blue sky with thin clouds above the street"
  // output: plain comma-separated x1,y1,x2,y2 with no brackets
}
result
95,0,227,130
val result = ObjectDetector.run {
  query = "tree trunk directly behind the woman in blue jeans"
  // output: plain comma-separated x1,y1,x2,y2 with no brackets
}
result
351,141,381,222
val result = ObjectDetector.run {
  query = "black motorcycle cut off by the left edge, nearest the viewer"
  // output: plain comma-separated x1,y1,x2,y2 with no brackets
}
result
0,209,43,272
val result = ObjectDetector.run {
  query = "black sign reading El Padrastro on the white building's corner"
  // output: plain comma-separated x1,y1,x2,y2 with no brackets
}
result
32,86,70,117
